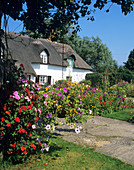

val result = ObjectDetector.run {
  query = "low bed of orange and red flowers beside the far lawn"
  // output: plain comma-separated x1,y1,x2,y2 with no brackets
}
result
80,86,133,115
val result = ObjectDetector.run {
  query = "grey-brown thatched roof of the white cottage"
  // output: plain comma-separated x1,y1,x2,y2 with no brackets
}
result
3,32,92,75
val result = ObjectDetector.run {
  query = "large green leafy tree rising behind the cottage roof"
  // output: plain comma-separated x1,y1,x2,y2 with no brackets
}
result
61,32,117,73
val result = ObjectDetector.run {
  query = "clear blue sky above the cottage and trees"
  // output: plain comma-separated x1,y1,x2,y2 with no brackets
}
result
3,4,134,65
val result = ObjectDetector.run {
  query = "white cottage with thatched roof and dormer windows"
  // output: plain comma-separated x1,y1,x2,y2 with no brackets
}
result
3,32,92,84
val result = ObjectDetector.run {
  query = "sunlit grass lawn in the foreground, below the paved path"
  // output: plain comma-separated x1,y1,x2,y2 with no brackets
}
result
0,137,134,170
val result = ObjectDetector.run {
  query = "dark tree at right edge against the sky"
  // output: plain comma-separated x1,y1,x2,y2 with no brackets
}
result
125,49,134,71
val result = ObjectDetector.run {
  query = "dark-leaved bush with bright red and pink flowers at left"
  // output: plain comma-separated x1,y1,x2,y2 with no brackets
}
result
0,80,44,162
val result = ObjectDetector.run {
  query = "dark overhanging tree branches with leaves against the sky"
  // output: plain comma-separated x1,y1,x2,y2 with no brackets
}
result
0,0,133,37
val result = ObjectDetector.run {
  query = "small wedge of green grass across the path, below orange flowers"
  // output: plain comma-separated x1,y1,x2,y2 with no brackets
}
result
102,109,134,122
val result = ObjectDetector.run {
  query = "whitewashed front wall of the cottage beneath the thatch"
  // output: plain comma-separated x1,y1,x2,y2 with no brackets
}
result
32,64,92,84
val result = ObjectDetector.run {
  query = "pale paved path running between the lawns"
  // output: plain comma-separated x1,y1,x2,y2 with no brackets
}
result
51,117,134,165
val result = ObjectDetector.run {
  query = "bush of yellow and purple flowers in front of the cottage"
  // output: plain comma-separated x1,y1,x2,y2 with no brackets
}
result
39,82,85,129
